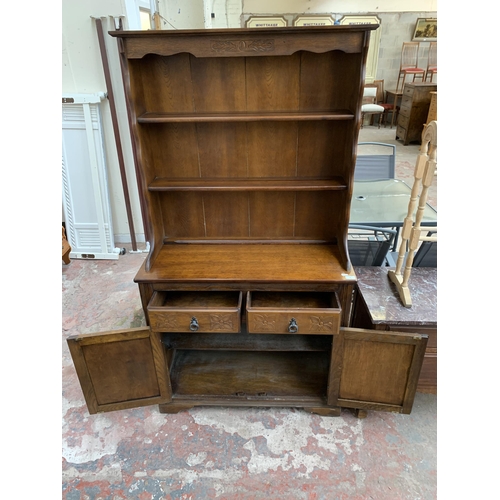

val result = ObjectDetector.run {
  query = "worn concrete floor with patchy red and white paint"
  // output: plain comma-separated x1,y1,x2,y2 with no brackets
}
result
62,127,437,500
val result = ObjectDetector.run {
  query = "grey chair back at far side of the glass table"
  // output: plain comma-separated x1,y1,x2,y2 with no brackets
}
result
354,142,396,181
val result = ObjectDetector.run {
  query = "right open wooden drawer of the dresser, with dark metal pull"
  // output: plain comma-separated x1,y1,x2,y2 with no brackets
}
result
246,292,342,335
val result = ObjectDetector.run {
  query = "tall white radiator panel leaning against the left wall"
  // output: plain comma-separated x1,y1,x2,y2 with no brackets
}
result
62,92,122,259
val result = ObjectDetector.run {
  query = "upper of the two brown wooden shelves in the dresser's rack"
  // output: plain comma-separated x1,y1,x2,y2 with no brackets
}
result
137,109,354,123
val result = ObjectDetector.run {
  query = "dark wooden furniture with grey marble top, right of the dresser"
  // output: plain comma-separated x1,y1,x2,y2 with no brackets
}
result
351,267,437,394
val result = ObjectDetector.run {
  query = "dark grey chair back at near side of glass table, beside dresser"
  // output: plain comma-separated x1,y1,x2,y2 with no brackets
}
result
347,224,396,267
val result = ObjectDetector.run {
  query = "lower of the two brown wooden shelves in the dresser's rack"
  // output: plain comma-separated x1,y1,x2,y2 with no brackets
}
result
148,177,347,191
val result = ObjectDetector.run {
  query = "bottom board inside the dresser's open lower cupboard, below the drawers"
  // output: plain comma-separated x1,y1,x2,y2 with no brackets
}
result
170,350,330,402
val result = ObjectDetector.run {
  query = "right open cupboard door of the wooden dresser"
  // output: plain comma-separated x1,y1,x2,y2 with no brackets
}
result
333,328,428,414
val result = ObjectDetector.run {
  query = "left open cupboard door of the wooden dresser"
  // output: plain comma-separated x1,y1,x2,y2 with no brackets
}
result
67,328,172,414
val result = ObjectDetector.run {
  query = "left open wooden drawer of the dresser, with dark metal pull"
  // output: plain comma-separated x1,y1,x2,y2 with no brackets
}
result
148,291,242,333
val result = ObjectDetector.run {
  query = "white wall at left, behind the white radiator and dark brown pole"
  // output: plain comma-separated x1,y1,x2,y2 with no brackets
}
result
62,0,144,243
